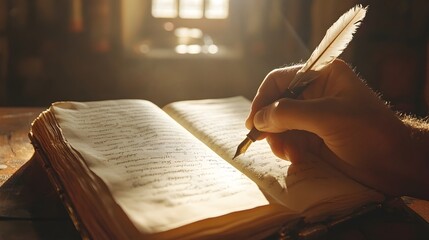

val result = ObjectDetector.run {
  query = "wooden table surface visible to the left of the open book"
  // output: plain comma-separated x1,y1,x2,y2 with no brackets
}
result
0,108,80,240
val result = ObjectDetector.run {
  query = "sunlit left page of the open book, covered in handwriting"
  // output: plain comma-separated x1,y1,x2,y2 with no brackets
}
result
53,100,268,233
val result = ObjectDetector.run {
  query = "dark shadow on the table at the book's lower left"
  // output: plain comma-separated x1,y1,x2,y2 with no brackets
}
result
0,157,81,240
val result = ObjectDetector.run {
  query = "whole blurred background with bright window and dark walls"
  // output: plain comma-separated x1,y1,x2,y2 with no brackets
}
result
0,0,429,116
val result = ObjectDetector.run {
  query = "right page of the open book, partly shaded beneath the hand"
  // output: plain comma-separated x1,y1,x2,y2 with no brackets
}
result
164,97,382,219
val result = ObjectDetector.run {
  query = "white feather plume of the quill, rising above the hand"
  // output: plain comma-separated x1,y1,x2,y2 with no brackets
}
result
289,5,367,89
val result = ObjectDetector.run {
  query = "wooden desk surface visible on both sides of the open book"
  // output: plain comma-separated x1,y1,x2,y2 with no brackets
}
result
0,107,429,239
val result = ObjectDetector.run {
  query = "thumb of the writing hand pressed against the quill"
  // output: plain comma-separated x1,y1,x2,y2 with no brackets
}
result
253,98,338,135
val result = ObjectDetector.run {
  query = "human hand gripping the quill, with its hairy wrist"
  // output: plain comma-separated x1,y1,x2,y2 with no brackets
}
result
246,60,428,196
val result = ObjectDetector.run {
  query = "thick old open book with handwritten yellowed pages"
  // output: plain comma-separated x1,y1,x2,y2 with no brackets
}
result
30,97,384,239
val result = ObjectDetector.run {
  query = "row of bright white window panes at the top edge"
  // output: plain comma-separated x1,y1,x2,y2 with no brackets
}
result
152,0,229,19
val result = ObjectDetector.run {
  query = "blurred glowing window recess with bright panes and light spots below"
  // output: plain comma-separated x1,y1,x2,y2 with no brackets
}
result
134,0,237,58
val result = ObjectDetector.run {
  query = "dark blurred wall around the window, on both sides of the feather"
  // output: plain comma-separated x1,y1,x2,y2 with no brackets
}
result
0,0,429,115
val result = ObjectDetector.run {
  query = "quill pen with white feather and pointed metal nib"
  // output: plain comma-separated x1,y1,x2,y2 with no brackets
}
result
233,5,367,159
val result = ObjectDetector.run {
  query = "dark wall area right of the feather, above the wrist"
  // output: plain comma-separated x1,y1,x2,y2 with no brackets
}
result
355,0,429,115
